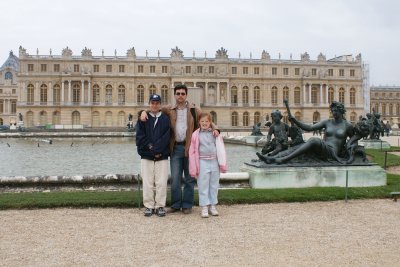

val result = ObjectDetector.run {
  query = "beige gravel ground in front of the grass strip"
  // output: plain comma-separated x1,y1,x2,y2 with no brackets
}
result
0,199,400,266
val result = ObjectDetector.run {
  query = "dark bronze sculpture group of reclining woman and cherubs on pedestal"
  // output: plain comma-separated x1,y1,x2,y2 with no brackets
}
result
256,100,371,164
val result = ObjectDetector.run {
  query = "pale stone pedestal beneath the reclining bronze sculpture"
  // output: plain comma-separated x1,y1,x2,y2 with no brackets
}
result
240,164,386,189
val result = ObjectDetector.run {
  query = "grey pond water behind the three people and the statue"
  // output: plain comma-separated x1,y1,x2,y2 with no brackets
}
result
0,137,261,176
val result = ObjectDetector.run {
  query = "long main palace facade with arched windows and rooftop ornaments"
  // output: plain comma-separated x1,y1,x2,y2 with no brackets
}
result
17,47,369,129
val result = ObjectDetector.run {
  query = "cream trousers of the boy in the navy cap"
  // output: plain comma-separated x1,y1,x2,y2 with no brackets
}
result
140,159,168,209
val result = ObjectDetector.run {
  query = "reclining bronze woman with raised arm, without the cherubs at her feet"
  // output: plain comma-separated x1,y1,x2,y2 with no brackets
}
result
256,100,369,164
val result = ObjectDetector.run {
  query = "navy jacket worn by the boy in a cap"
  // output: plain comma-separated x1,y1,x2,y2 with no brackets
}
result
136,113,171,160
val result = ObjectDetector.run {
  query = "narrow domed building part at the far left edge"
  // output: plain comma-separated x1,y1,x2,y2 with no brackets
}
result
0,52,19,125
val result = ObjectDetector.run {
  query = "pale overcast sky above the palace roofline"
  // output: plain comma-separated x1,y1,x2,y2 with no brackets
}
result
0,0,400,86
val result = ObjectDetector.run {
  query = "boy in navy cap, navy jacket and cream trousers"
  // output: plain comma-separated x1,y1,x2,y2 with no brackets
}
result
136,94,171,217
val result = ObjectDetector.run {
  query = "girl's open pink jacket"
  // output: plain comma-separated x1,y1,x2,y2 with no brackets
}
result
189,128,227,177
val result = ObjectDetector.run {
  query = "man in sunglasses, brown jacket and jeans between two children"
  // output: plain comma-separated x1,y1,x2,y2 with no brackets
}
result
140,84,219,214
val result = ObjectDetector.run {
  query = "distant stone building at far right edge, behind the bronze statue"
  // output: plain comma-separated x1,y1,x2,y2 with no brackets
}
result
370,86,400,128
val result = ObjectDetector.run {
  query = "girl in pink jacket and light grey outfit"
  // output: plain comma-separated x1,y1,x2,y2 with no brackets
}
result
189,113,226,218
